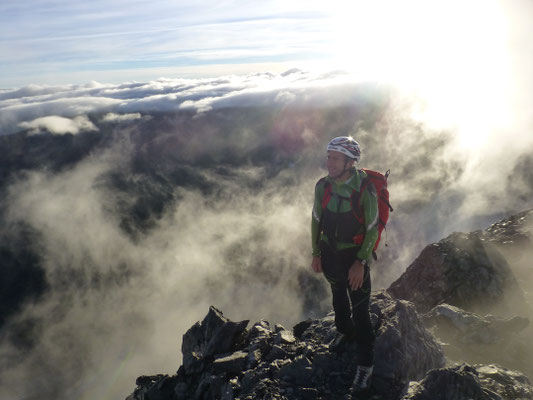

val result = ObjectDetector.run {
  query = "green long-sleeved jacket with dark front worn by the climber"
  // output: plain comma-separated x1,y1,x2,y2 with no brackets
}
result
311,167,379,260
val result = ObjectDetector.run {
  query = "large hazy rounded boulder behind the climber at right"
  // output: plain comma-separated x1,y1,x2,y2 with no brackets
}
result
388,232,525,314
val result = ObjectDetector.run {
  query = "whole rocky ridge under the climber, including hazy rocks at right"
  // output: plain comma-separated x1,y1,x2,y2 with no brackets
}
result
127,211,533,400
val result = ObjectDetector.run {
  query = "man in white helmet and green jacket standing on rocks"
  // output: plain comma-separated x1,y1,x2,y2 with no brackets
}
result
311,136,378,392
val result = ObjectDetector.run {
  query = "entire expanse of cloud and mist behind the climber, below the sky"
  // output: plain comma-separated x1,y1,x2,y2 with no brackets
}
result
0,66,533,399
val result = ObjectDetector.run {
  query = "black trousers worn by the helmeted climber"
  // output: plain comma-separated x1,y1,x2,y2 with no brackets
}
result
320,243,376,366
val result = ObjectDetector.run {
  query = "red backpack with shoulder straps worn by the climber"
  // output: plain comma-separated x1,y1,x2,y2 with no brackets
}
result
322,168,394,260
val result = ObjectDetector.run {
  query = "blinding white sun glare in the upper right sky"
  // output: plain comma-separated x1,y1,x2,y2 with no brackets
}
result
324,0,510,148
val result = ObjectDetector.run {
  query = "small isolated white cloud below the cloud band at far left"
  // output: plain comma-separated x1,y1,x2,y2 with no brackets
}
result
19,115,98,135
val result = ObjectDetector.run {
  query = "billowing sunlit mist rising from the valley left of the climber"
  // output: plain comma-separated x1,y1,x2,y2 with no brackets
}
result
0,148,324,398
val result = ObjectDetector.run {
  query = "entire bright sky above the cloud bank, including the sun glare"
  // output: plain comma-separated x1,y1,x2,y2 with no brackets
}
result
0,0,531,88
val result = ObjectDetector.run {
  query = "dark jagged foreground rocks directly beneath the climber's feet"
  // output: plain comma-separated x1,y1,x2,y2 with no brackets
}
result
128,291,445,400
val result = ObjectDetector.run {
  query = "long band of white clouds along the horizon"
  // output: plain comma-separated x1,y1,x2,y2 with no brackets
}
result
0,71,366,134
